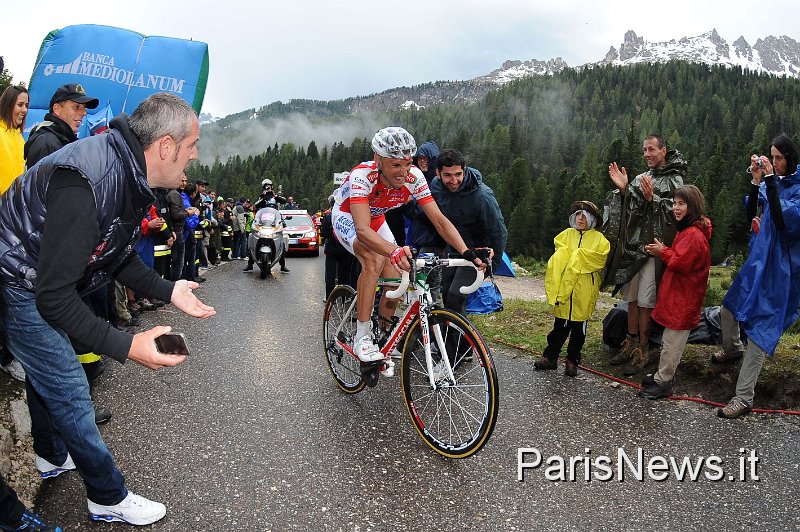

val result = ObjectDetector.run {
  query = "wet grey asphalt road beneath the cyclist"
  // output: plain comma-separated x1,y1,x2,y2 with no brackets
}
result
37,257,800,532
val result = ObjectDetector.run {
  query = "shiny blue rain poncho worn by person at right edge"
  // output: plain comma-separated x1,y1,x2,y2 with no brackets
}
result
722,167,800,355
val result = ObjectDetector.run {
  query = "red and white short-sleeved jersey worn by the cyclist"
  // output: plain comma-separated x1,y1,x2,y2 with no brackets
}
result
333,161,433,228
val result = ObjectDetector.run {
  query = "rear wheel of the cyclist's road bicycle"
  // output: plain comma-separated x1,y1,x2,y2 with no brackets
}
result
322,285,366,393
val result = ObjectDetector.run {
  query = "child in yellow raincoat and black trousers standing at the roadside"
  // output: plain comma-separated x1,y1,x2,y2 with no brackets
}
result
534,201,610,377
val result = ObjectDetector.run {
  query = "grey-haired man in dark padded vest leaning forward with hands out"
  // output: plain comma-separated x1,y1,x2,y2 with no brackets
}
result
0,93,215,525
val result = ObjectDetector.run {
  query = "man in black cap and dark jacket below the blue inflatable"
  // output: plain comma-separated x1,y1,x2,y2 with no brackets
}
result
25,83,100,168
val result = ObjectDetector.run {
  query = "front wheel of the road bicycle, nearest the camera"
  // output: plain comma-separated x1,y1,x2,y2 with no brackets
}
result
400,309,499,458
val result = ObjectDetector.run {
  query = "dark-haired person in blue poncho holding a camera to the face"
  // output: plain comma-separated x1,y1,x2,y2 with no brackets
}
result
717,135,800,419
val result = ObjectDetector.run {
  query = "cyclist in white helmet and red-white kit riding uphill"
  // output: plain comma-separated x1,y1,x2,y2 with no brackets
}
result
331,127,486,377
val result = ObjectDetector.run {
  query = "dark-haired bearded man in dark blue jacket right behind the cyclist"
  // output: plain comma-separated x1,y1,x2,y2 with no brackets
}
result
430,149,508,313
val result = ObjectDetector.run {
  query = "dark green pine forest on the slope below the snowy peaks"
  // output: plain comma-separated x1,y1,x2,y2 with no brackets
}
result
187,61,800,264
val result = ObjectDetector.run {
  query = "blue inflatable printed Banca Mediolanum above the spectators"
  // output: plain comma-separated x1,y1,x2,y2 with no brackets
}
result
25,24,208,136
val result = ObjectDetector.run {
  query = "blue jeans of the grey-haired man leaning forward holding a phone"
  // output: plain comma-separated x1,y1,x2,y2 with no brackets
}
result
0,286,128,505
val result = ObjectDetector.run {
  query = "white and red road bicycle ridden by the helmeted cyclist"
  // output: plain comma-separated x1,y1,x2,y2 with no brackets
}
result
323,256,499,458
